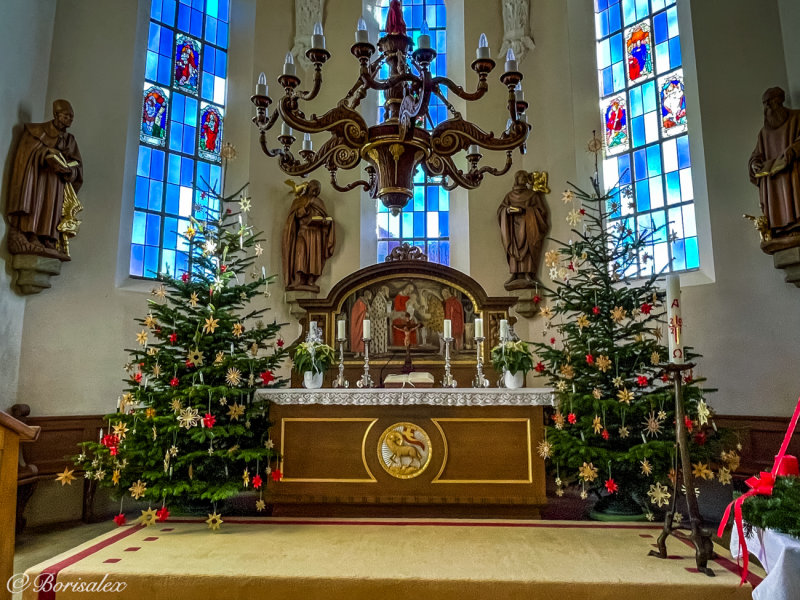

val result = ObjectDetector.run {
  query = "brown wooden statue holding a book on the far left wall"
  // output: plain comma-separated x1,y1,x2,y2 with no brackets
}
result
7,100,83,261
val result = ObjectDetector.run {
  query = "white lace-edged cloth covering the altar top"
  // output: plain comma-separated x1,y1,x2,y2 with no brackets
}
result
256,388,553,406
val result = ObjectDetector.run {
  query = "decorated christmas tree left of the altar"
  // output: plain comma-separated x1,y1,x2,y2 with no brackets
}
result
65,146,286,529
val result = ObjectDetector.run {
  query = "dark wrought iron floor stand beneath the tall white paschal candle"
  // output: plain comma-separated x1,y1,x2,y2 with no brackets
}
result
650,363,715,577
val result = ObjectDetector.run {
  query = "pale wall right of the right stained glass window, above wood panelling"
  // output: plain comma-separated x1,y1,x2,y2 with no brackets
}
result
682,0,800,416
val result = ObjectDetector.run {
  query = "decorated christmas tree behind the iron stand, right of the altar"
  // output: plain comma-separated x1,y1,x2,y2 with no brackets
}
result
534,138,738,518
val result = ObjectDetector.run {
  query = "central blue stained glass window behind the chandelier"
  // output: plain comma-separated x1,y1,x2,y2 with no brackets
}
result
377,0,450,265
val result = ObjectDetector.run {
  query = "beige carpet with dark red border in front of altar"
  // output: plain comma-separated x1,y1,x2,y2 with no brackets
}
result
18,518,764,600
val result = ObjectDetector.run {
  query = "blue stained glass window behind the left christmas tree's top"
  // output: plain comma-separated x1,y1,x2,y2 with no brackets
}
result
129,0,230,279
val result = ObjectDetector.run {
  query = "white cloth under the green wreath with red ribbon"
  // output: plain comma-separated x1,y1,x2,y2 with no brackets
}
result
731,527,800,600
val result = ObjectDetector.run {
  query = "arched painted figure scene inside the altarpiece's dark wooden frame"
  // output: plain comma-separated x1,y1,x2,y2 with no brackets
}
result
337,277,476,359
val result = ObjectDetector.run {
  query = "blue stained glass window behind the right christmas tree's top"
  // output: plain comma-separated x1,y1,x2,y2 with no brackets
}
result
595,0,700,277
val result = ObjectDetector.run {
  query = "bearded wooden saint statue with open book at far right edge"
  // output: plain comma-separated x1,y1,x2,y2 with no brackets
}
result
748,87,800,252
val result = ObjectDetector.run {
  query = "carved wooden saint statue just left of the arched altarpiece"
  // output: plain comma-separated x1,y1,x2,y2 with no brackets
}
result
283,179,336,293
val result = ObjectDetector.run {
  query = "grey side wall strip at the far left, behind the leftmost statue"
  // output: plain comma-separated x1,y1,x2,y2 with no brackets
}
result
0,0,56,410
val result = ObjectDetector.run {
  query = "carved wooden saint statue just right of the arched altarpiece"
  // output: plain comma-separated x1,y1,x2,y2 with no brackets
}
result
497,171,550,290
